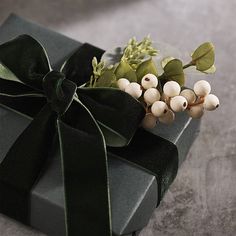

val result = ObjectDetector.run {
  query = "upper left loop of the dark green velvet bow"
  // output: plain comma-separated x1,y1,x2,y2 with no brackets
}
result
0,35,50,90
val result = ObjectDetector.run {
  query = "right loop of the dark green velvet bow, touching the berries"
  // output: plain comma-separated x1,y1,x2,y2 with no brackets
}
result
77,88,145,147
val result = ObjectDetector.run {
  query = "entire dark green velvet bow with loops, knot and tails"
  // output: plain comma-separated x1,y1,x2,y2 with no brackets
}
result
0,35,145,236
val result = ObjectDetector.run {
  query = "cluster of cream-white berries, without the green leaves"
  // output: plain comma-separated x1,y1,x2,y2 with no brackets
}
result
118,77,220,129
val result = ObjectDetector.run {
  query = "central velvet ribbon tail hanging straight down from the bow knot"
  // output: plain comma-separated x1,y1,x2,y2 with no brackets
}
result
58,103,112,236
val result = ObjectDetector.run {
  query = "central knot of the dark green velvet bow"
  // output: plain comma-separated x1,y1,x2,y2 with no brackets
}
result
43,71,77,115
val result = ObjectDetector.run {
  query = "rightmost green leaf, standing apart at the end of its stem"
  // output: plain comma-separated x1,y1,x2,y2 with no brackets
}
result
192,42,215,71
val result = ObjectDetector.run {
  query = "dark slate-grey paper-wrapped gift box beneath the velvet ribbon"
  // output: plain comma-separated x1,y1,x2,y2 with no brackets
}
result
0,15,200,236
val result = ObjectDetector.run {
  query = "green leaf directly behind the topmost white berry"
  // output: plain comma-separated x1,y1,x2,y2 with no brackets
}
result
136,58,158,83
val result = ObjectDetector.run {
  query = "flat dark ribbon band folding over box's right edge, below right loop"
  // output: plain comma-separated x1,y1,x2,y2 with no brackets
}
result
108,129,179,205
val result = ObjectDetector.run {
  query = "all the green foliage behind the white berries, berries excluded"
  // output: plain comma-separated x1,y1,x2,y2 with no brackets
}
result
87,36,216,88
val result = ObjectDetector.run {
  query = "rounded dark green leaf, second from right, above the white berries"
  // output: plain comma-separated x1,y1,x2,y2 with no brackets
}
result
163,59,185,86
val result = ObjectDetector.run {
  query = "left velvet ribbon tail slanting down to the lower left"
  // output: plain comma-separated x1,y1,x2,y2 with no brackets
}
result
0,105,56,224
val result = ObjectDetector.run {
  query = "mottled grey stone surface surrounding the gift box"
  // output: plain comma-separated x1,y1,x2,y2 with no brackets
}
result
0,0,236,236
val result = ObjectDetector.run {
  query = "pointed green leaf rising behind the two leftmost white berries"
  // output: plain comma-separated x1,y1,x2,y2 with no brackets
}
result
115,60,137,82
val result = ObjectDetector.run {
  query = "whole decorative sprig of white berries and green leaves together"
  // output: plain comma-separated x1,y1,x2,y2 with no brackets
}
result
90,37,220,129
